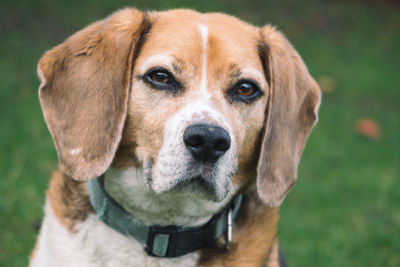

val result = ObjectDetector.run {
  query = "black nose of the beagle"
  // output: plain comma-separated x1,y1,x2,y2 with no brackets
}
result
183,124,231,163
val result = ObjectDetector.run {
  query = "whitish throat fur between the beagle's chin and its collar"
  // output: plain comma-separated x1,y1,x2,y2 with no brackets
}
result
104,167,235,227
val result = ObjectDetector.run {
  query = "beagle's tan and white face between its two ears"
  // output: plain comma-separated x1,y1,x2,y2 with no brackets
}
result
119,11,268,201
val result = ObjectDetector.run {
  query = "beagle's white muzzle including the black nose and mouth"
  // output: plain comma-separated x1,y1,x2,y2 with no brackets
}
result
150,122,237,202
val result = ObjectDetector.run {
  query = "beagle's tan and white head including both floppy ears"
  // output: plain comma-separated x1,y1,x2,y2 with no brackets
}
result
38,9,320,206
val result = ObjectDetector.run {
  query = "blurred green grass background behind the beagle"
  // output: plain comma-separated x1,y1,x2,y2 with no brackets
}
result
0,0,400,266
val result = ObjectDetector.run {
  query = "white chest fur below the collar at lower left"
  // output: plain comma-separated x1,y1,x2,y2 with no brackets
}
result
31,203,199,267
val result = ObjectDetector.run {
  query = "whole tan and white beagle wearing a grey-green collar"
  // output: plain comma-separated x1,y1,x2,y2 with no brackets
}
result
30,9,320,267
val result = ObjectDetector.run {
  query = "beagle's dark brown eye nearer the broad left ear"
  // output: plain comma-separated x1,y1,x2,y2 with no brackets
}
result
142,68,180,93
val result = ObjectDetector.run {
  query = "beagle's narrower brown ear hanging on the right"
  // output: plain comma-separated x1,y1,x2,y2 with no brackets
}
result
257,26,321,206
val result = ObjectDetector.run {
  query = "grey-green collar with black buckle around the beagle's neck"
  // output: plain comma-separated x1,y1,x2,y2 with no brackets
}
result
88,176,242,258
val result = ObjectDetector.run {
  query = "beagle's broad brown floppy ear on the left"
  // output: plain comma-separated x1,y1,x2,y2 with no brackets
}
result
38,9,150,180
